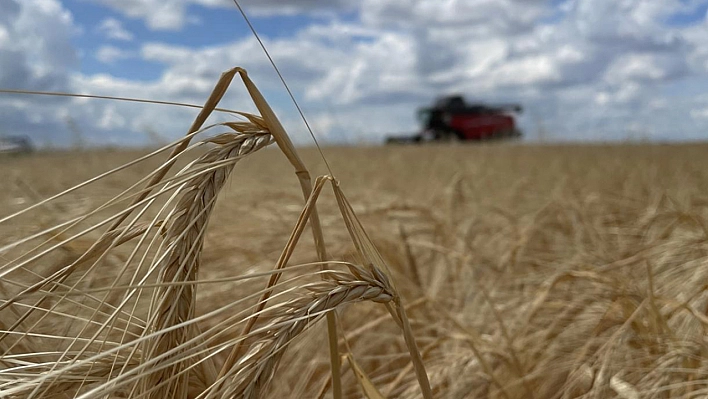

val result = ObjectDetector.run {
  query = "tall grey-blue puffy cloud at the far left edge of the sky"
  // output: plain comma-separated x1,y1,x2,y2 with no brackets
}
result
0,0,78,146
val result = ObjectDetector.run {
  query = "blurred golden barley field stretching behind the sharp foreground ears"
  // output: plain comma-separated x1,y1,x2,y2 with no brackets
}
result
0,137,708,399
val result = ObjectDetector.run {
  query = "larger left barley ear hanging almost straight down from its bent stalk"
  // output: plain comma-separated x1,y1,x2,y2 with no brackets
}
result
139,130,271,399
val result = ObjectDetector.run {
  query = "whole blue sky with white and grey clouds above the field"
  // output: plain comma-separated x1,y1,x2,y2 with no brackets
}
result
0,0,708,146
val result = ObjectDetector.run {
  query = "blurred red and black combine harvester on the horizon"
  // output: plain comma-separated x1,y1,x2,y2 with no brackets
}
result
386,96,521,144
